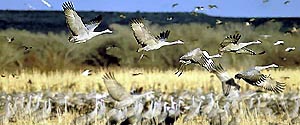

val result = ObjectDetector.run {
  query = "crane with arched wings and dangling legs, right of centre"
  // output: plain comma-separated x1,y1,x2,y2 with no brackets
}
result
175,48,222,76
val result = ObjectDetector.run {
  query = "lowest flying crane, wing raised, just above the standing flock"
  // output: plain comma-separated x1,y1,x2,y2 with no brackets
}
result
103,72,154,109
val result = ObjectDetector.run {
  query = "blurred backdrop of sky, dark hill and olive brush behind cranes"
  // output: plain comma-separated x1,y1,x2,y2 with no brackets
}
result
0,0,300,71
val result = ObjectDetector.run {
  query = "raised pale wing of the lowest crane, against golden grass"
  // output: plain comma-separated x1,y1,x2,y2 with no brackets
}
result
103,72,131,101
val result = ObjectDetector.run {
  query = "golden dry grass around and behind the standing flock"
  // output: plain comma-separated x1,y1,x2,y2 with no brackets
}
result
0,68,300,125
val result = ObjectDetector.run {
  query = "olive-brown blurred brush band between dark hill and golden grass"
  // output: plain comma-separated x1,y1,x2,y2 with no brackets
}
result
0,21,300,71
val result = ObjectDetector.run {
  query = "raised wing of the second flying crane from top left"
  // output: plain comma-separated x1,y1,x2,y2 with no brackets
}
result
130,19,158,47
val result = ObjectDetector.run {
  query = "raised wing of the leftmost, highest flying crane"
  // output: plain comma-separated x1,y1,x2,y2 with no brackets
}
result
62,1,87,36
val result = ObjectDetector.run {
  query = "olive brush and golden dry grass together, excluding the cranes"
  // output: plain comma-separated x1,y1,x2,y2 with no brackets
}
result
0,21,300,125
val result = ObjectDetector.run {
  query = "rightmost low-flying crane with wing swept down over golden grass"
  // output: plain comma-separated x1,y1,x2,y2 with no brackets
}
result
235,64,285,93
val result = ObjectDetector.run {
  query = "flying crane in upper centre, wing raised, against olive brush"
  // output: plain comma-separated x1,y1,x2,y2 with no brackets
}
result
130,19,184,59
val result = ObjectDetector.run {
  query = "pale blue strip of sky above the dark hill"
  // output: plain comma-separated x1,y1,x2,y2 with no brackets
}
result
0,0,300,17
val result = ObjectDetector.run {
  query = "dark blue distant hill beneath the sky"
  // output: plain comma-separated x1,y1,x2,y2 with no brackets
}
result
0,10,300,33
